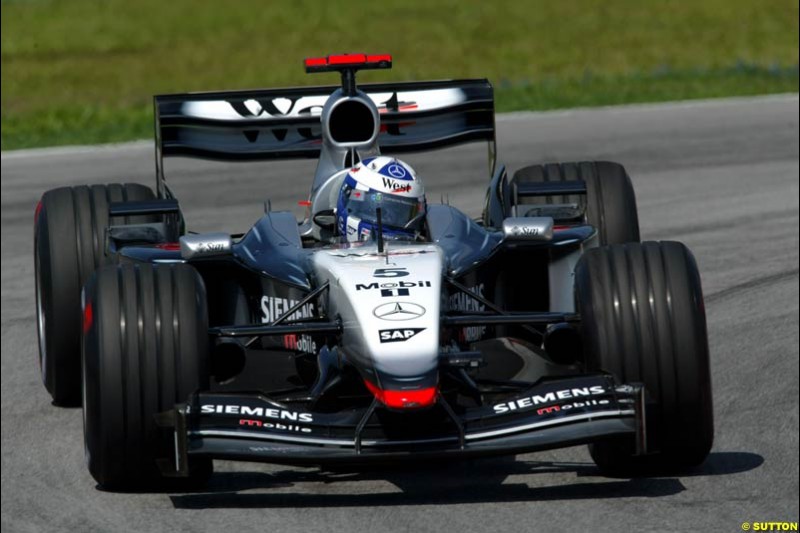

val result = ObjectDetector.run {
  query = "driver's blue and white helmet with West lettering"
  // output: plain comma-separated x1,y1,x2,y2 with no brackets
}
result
336,156,425,241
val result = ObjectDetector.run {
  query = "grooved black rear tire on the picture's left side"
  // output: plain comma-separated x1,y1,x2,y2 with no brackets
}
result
34,183,157,406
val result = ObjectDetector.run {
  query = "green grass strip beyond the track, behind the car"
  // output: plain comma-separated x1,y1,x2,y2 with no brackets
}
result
1,0,798,150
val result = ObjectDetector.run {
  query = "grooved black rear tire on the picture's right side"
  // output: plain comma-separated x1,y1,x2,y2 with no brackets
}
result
510,161,641,246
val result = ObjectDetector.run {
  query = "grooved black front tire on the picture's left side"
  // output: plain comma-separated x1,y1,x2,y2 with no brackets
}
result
83,264,212,490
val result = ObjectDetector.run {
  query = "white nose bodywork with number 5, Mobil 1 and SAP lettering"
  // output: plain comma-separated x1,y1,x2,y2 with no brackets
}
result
313,242,443,388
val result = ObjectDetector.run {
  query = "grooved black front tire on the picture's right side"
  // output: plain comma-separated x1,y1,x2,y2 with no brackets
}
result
575,242,714,476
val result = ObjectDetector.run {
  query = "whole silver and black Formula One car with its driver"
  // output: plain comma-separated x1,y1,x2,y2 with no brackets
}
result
35,54,713,489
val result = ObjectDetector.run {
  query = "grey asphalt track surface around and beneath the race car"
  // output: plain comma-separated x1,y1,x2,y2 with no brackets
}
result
2,94,798,533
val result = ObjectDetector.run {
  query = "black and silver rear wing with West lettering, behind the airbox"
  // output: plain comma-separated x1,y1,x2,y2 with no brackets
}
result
154,79,495,197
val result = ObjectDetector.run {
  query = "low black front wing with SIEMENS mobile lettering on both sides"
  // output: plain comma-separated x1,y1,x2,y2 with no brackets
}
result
160,375,646,475
